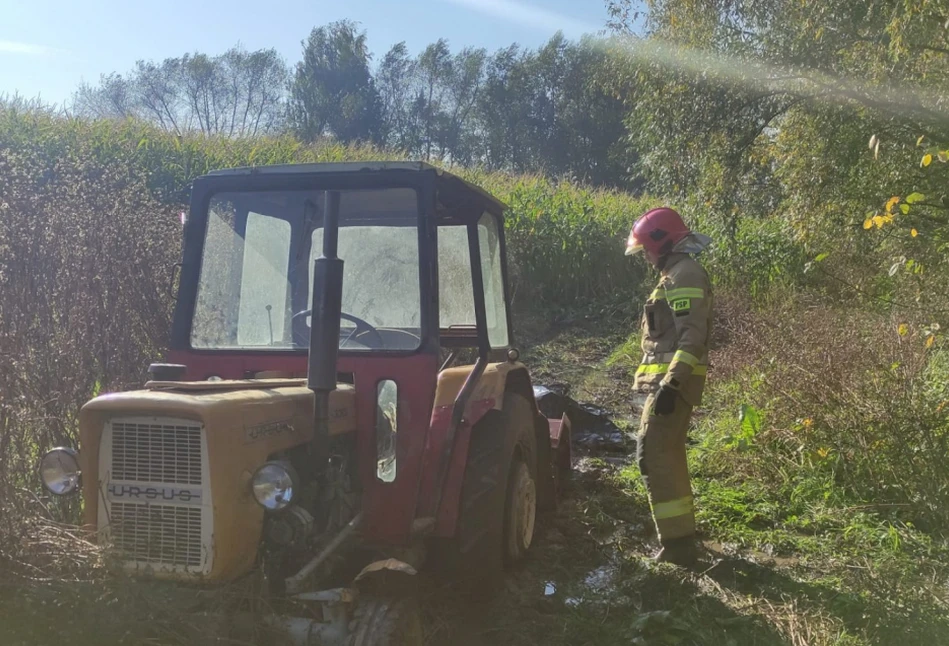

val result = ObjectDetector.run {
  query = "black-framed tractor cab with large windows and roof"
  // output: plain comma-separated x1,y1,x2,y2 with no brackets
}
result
172,163,511,360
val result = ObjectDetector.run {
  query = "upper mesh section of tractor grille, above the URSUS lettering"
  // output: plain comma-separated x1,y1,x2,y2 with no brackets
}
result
112,420,201,485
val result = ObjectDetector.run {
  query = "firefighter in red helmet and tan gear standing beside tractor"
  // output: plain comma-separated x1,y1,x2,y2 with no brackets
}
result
626,208,712,567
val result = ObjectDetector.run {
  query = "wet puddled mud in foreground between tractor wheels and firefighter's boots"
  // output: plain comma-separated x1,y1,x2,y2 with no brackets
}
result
422,457,811,646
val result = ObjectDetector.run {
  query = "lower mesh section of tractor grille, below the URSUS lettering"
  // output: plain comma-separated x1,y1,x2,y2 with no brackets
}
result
111,502,202,567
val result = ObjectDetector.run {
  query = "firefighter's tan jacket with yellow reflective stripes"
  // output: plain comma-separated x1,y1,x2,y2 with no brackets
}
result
636,253,712,406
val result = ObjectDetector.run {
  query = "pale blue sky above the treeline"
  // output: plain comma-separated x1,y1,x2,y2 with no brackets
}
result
0,0,607,103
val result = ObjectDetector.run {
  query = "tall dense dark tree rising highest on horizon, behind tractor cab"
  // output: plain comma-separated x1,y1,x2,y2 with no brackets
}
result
289,20,381,141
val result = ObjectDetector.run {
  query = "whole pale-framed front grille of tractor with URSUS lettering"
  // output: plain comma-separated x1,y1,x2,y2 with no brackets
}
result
99,417,213,572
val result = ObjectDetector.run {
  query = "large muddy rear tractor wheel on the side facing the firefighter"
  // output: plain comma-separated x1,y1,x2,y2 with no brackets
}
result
449,392,537,596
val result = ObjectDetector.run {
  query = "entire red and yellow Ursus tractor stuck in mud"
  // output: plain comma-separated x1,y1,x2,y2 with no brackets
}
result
40,163,570,646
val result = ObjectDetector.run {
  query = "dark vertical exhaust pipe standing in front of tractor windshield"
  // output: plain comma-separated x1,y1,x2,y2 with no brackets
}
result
307,191,343,474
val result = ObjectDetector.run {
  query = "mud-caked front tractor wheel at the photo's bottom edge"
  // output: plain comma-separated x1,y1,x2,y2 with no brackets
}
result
349,597,425,646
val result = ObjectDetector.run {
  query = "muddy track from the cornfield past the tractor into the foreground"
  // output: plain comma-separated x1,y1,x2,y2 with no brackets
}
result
414,320,764,646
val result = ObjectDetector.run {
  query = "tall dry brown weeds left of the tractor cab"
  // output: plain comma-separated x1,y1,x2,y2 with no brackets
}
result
0,135,180,496
